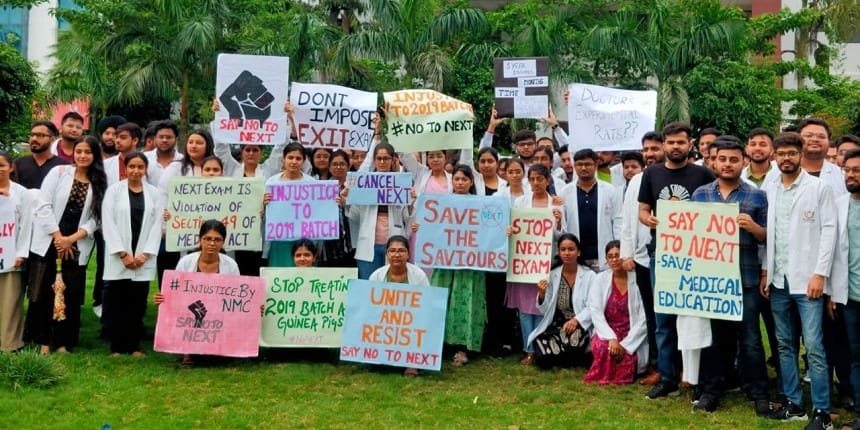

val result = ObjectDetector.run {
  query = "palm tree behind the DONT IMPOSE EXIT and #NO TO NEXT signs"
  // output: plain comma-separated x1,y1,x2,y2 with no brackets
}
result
333,0,489,89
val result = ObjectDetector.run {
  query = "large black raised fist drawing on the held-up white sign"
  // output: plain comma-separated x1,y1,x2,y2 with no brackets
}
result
218,70,275,126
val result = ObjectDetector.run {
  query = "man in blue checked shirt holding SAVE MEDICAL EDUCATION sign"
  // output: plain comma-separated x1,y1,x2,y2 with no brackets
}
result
691,136,770,416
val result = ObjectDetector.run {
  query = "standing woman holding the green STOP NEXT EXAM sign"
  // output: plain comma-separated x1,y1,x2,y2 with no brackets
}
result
505,164,567,366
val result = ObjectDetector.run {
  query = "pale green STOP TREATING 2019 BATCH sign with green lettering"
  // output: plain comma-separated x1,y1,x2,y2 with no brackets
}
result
260,267,358,348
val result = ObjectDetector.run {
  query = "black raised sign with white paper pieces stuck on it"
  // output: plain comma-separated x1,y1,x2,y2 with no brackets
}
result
493,57,549,119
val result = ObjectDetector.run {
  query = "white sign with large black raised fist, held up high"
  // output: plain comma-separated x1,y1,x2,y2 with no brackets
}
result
212,54,290,145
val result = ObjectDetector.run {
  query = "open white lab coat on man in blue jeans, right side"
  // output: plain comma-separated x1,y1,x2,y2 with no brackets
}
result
763,170,836,295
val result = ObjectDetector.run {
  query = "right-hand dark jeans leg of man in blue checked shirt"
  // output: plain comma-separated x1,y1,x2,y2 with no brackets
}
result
739,287,770,400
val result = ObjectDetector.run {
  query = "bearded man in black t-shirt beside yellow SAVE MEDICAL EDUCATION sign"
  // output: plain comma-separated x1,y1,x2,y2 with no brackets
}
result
639,122,716,399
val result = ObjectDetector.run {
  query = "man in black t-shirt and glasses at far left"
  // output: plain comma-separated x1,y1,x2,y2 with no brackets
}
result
12,121,69,189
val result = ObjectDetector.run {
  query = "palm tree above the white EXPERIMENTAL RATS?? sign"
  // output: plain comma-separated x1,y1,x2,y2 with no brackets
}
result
584,0,747,126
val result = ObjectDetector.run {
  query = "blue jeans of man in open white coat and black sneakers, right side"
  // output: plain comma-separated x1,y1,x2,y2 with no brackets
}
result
770,281,830,411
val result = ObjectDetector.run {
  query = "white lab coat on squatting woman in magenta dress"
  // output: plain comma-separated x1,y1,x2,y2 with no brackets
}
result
588,270,648,372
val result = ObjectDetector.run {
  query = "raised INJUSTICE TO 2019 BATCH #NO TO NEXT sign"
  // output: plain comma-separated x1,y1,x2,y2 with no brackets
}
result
384,90,475,152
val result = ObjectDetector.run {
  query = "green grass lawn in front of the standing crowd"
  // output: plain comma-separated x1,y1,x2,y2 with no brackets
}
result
0,268,842,430
